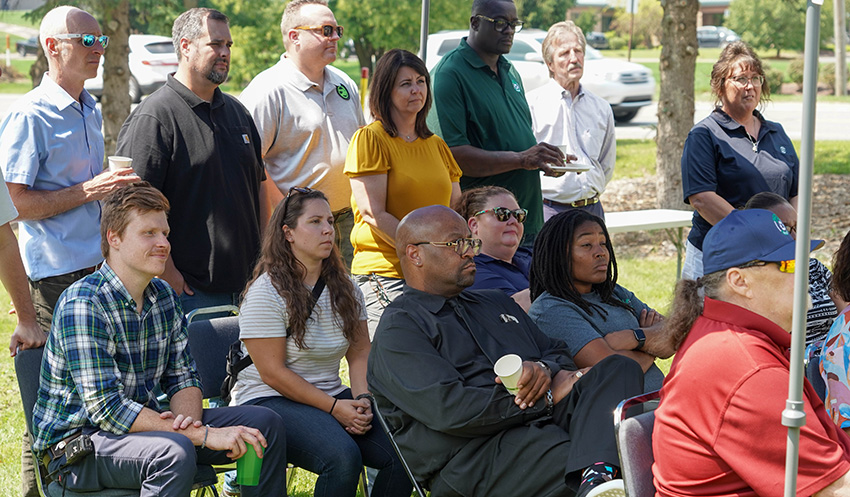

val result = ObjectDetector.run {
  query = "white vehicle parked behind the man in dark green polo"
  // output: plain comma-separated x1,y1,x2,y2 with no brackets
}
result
425,29,655,122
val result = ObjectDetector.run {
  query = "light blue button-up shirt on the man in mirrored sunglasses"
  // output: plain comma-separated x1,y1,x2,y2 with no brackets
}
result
0,74,103,281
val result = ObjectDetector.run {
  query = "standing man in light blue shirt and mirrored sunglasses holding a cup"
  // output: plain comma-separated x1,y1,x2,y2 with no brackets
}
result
0,6,139,495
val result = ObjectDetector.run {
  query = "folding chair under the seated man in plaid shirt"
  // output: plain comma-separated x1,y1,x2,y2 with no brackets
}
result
15,347,218,497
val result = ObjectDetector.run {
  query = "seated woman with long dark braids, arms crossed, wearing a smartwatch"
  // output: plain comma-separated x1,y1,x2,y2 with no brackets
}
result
528,209,673,392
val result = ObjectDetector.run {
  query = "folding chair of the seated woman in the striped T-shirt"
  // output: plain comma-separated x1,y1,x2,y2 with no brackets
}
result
187,312,369,497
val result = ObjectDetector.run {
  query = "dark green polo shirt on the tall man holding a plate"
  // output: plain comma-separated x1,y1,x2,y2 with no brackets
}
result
428,38,543,243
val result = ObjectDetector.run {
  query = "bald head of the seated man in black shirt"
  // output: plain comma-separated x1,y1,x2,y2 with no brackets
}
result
396,205,475,297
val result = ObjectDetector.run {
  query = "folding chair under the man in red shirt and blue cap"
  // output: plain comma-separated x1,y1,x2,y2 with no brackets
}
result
614,390,660,497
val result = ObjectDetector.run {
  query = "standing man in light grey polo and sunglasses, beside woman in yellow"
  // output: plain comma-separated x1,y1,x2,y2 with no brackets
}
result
239,0,366,267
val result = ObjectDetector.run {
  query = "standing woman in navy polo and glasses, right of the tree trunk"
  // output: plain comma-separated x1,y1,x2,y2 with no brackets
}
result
682,41,800,279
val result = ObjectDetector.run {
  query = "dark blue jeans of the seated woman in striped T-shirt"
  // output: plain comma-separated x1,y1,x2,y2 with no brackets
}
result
248,388,412,497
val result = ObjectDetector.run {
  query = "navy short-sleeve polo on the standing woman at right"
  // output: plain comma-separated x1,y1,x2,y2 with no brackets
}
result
682,107,800,250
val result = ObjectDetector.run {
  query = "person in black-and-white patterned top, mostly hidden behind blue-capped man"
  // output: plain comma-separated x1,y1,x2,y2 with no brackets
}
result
745,192,838,345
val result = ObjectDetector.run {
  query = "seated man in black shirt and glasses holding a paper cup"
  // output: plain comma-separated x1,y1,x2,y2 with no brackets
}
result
367,205,643,497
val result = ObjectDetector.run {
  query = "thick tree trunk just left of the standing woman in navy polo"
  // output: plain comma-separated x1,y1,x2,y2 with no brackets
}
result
655,0,699,209
